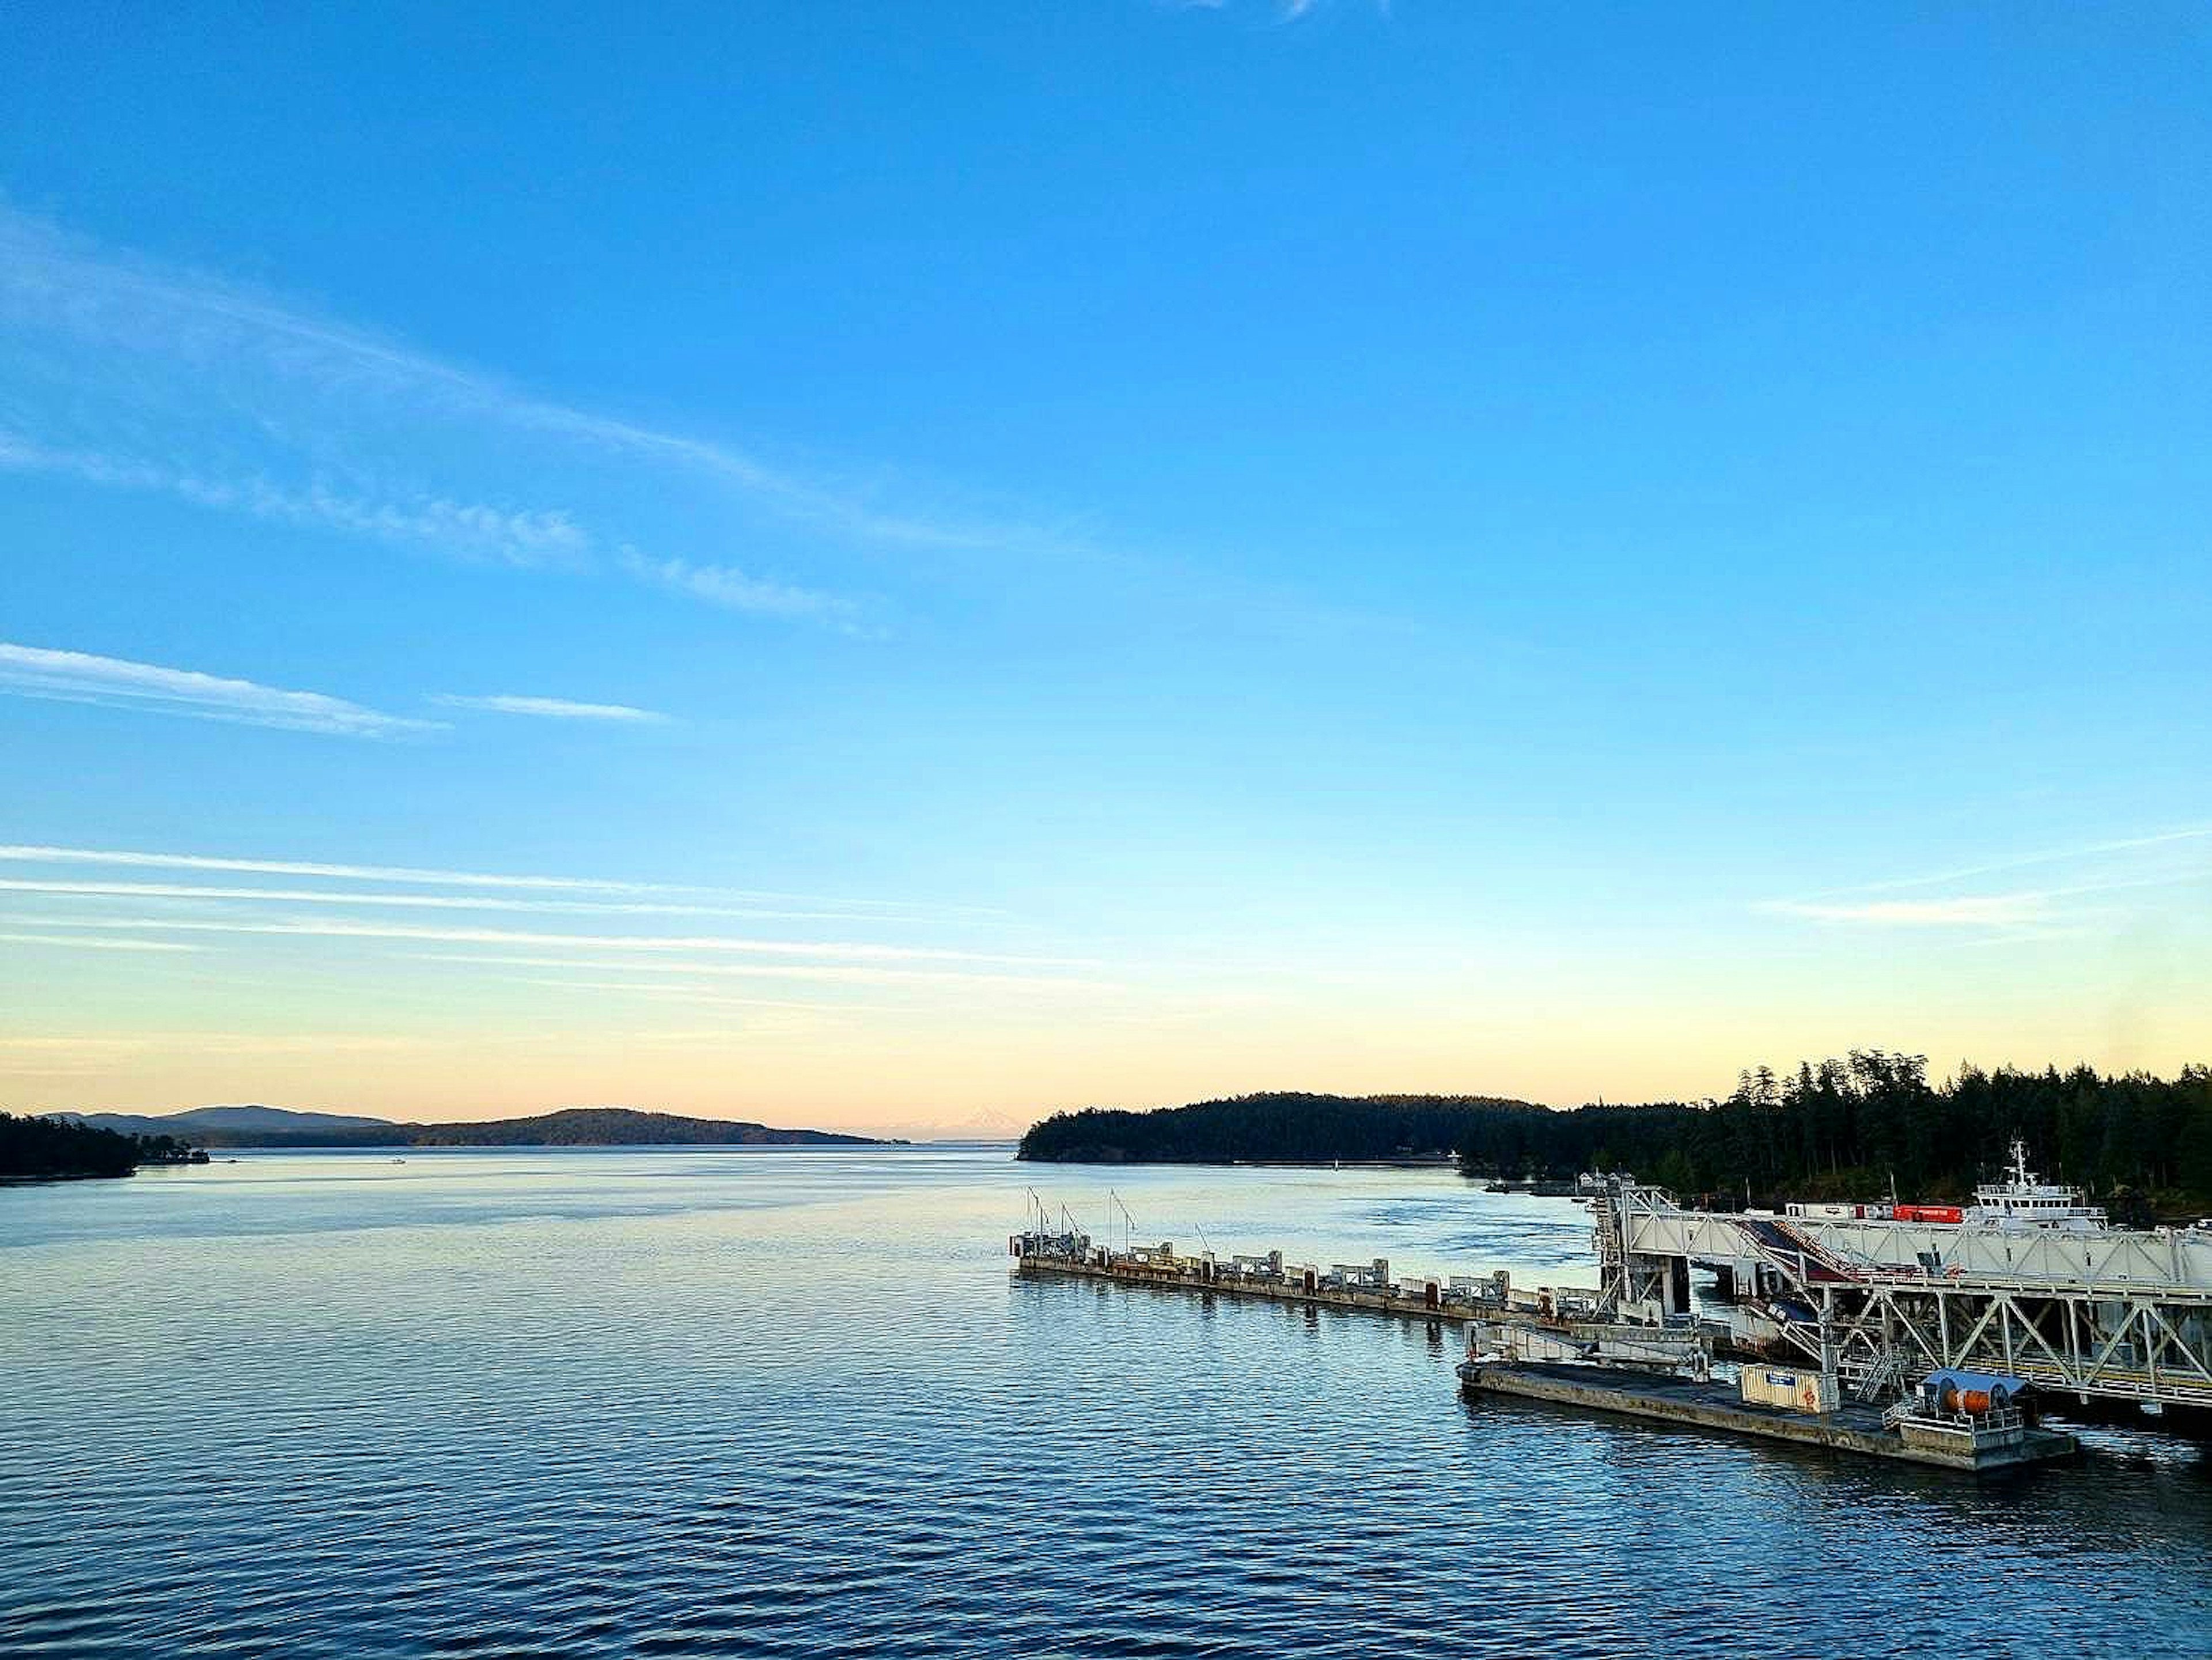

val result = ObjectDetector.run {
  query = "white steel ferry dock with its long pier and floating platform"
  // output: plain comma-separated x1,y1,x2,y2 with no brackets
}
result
1006,1178,2212,1472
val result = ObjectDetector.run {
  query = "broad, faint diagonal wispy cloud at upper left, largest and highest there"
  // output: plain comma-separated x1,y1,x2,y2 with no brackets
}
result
0,206,1059,624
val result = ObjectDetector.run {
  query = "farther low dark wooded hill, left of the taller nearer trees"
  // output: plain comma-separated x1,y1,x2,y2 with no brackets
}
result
1016,1091,1551,1164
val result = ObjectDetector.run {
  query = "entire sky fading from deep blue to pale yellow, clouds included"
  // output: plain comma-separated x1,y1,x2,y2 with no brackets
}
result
0,0,2212,1126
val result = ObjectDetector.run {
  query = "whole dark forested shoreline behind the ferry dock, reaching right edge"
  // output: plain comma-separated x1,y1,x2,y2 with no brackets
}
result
1017,1067,2212,1217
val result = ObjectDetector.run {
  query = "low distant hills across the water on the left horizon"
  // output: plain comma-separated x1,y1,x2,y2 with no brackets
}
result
48,1107,885,1147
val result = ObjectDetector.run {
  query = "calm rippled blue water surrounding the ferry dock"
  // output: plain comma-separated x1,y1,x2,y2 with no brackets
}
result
0,1149,2212,1660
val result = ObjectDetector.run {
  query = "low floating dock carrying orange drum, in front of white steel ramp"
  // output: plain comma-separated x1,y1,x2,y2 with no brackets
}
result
1460,1359,2081,1470
